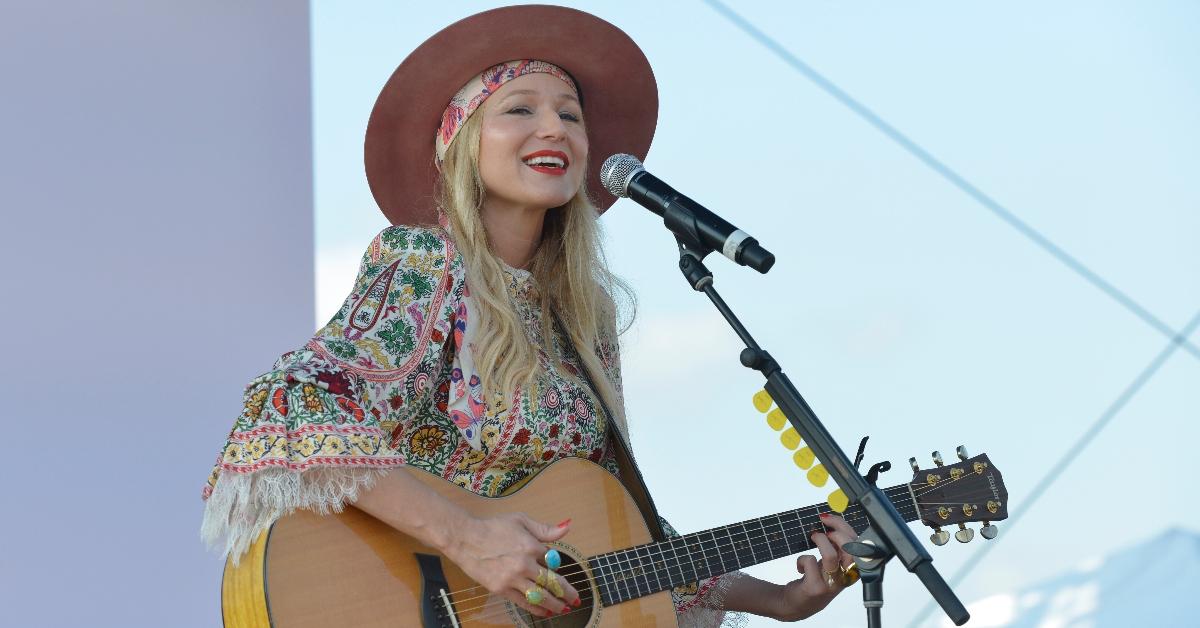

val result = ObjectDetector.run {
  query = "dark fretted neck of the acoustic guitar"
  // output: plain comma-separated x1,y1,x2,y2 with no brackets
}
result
588,484,920,606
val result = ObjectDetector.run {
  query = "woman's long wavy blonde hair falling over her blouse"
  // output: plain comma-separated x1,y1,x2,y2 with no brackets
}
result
440,113,636,425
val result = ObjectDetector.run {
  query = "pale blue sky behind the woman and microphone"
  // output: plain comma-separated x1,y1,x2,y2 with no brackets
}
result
312,0,1200,626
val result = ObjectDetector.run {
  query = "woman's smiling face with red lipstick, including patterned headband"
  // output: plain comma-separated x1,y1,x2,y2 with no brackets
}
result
478,72,588,216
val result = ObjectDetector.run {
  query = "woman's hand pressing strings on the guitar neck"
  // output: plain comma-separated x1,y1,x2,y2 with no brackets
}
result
776,514,858,622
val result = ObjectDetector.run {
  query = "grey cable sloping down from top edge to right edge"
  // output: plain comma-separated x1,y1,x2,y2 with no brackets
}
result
703,0,1200,359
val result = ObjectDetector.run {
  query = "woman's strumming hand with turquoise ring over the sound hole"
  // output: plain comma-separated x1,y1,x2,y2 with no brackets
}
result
445,513,580,617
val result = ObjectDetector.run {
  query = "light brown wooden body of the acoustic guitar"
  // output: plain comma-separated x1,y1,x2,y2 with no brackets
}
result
222,459,678,628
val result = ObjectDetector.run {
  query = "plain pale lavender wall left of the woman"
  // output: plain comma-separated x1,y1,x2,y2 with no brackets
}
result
0,0,313,627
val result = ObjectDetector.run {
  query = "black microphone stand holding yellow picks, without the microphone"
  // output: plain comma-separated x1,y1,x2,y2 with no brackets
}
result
662,203,971,628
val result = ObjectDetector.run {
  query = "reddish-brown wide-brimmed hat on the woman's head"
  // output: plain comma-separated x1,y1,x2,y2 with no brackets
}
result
365,5,659,225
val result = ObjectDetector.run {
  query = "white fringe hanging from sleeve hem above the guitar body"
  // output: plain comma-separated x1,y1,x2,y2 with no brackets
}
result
200,467,390,566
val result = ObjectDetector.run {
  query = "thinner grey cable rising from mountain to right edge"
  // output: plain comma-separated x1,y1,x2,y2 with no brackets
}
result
908,312,1200,628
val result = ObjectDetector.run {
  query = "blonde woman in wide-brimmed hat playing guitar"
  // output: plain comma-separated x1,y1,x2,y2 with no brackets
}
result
203,6,853,626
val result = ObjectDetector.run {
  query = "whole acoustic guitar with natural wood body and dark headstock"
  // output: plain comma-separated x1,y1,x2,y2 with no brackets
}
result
222,449,1008,628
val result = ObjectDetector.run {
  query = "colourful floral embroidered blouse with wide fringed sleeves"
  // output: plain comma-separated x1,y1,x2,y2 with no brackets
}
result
202,226,727,626
